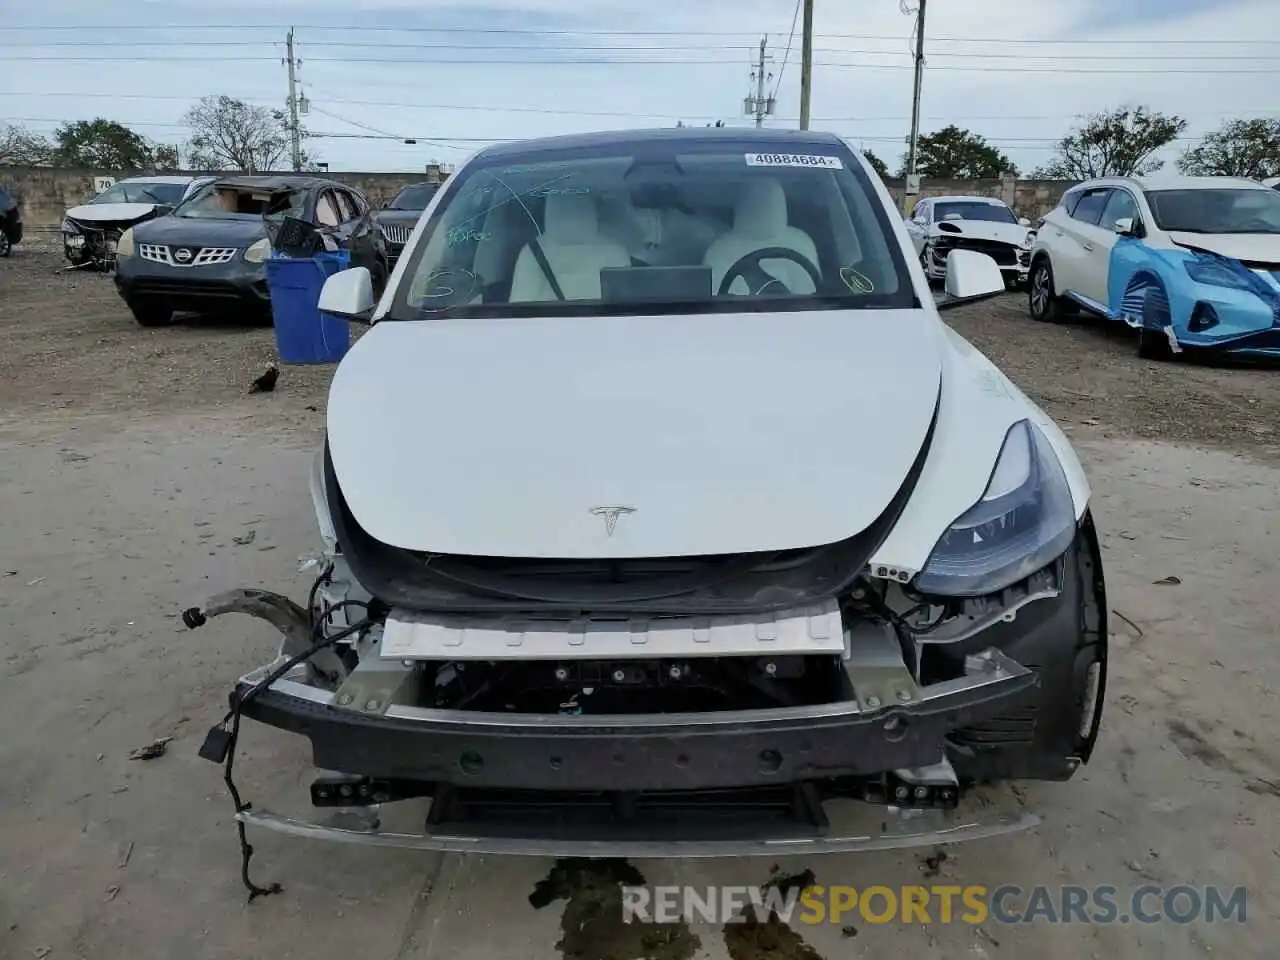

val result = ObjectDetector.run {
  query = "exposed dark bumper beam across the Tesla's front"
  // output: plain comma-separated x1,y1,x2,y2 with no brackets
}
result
237,649,1038,791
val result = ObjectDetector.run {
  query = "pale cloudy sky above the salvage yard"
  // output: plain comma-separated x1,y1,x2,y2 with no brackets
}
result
0,0,1280,173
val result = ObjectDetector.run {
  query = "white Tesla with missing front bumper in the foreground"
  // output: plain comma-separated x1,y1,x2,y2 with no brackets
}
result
184,129,1107,892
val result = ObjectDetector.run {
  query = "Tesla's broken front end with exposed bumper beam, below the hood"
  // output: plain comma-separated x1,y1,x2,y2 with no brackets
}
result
186,445,1106,856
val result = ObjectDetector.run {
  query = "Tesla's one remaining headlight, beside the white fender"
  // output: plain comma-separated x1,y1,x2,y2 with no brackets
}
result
915,420,1075,596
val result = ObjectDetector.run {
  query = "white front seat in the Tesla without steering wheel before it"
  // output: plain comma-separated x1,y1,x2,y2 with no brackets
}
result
511,193,631,303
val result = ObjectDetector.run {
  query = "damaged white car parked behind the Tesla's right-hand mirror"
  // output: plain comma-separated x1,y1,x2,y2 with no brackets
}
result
906,197,1036,288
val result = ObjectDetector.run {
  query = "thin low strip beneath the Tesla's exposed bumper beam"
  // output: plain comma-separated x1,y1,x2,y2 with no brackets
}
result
237,800,1039,860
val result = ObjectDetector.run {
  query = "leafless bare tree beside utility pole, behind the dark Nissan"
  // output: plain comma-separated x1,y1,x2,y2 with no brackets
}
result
183,96,289,173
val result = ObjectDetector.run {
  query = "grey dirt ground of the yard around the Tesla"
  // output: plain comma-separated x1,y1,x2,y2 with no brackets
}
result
0,248,1280,960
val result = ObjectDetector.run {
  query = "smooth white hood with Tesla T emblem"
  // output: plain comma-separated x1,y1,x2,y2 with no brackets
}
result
328,310,945,558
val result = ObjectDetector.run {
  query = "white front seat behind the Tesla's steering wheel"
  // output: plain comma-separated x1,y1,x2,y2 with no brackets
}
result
703,178,819,293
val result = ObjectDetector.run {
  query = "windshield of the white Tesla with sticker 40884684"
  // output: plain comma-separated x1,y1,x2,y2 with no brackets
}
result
388,138,915,320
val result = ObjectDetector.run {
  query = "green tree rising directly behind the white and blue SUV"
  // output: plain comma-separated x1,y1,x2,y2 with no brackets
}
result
1036,106,1187,180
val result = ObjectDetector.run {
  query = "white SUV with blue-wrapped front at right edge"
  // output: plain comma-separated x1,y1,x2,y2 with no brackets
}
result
1029,177,1280,360
